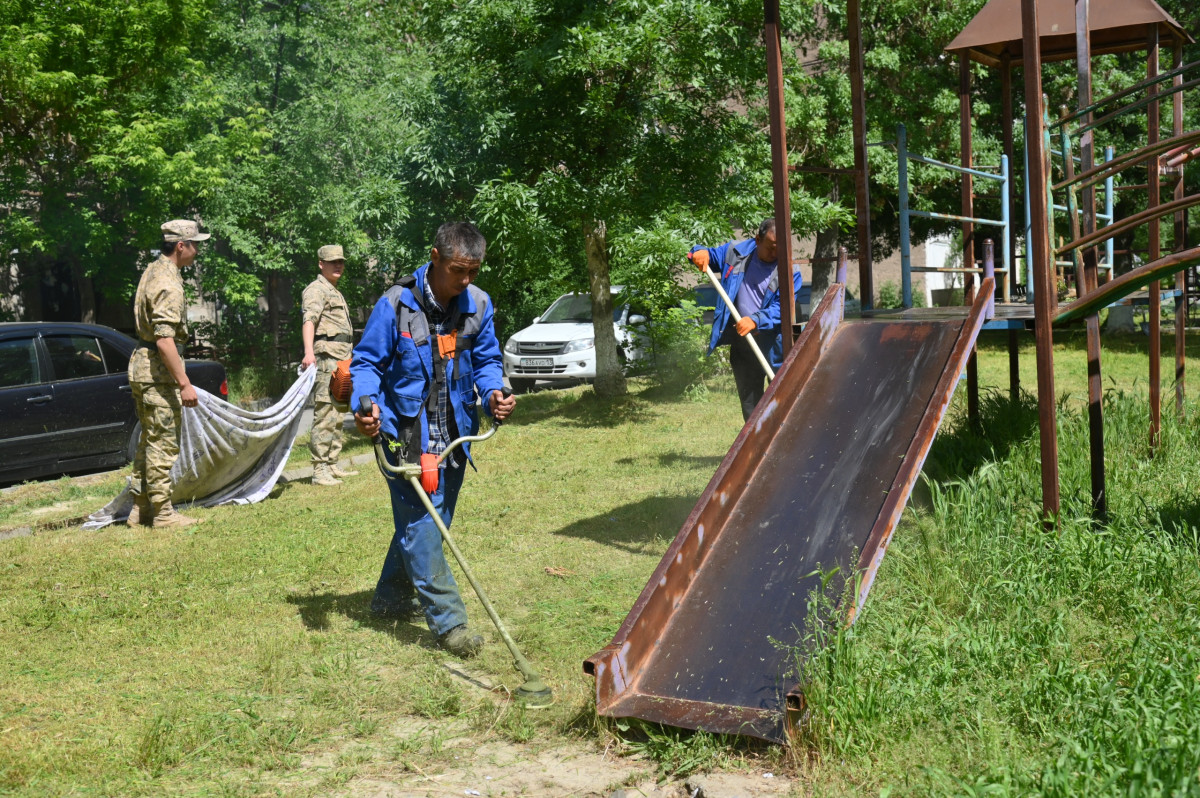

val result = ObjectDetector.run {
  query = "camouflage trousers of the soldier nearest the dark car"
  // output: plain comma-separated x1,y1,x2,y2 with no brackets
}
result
130,382,182,508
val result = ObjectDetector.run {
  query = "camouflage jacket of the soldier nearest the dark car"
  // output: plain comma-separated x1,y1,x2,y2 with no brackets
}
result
128,256,187,388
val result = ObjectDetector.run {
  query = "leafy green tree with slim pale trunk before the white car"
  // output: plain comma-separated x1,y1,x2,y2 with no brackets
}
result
405,0,816,392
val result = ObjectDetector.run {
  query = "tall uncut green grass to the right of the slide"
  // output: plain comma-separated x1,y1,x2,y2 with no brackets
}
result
802,391,1200,796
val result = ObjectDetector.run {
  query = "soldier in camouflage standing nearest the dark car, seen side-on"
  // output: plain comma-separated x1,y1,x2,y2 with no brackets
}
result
128,220,209,529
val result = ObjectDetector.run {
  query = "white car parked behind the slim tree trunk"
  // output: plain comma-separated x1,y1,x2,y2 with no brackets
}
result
504,286,646,390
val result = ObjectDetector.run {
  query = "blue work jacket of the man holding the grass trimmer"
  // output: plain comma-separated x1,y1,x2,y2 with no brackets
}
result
350,263,504,458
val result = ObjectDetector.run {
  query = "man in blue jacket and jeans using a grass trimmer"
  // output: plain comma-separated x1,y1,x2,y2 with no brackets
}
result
350,222,516,656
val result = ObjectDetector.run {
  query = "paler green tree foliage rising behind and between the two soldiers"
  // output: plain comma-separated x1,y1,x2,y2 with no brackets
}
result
205,0,427,361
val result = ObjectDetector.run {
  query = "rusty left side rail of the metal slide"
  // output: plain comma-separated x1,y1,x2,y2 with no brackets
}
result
583,283,846,715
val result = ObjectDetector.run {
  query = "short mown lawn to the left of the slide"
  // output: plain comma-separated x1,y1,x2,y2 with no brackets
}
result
0,376,740,794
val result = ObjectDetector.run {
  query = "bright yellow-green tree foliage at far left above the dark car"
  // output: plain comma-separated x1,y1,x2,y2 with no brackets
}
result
0,0,265,319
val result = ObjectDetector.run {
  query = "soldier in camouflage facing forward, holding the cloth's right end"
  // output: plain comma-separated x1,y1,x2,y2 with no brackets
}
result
301,244,358,485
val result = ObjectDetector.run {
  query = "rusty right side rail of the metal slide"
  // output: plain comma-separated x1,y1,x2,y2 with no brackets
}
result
847,277,996,623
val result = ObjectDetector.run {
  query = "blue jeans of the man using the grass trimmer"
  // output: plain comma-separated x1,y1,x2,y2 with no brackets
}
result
371,449,467,635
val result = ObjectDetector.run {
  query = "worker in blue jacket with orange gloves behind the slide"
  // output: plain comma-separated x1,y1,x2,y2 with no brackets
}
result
688,218,802,420
